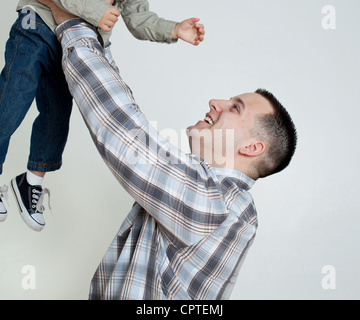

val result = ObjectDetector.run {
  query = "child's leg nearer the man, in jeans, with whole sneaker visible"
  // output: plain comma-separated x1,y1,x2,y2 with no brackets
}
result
11,65,72,231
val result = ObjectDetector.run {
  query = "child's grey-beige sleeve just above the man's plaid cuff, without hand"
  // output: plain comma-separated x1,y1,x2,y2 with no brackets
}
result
53,0,111,27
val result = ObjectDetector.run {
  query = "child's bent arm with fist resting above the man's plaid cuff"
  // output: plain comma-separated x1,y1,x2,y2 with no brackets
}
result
53,0,120,32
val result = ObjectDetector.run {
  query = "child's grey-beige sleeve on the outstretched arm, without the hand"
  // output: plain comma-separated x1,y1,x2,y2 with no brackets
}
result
121,0,177,43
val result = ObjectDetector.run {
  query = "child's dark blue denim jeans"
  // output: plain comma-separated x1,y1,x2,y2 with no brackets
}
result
0,13,72,174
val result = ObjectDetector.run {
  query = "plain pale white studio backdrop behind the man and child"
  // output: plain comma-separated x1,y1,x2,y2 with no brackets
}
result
0,0,360,299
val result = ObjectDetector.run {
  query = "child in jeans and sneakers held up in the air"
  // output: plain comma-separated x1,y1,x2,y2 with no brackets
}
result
0,0,204,231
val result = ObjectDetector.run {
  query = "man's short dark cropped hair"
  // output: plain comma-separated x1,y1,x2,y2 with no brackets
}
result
255,89,297,178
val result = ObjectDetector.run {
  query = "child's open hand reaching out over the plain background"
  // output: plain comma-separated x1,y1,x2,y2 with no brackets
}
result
172,18,205,46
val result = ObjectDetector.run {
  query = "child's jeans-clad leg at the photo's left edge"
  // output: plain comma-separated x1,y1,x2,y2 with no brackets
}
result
0,14,44,174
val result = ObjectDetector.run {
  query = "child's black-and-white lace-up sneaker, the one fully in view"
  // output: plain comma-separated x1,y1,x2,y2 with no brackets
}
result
11,173,50,231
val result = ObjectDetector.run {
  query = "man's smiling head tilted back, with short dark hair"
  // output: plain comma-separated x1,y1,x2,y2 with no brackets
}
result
188,89,297,180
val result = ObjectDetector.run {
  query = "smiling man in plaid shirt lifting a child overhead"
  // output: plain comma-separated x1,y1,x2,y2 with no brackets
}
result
39,0,296,300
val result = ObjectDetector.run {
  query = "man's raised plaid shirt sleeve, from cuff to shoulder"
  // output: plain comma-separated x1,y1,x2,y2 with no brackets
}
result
56,19,228,244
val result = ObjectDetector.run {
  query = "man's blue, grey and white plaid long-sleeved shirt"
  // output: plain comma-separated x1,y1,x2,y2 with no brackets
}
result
57,19,257,300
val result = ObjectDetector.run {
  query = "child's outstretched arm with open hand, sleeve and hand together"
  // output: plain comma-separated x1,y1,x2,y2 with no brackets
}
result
121,0,205,45
